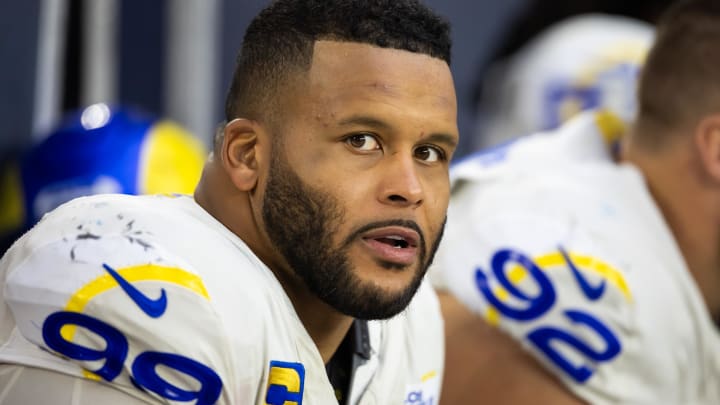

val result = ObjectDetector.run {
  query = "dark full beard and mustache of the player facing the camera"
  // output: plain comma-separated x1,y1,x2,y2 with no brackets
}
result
262,148,444,320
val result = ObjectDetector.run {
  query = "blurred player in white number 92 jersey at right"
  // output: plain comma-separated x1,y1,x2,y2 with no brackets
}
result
434,0,720,404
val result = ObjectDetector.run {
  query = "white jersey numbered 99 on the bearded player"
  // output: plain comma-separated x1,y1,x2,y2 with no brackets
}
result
0,195,443,405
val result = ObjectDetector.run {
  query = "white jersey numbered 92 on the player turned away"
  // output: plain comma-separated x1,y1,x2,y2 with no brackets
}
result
431,113,720,405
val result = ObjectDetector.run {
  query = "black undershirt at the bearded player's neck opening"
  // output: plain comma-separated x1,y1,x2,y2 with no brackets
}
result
325,319,370,405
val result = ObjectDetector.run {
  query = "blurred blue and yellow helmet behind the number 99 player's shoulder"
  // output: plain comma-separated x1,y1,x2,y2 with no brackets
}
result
0,104,206,253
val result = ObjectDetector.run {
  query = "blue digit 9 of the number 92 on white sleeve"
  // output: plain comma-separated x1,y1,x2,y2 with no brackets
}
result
475,249,555,321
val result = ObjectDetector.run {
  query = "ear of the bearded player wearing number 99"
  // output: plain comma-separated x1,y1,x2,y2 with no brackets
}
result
220,118,262,191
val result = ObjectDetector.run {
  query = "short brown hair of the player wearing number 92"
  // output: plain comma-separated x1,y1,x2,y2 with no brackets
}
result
635,0,720,147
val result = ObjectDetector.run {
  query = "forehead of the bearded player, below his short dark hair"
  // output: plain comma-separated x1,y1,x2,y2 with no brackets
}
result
296,41,457,132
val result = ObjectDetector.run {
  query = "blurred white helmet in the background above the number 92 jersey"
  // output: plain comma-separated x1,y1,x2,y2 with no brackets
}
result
473,14,653,149
